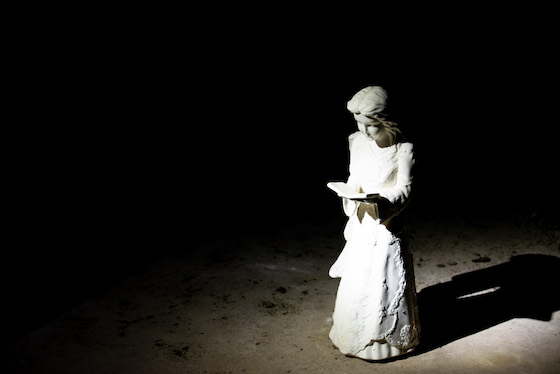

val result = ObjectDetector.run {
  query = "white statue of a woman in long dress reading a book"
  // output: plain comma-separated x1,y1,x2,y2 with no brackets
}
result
328,86,420,360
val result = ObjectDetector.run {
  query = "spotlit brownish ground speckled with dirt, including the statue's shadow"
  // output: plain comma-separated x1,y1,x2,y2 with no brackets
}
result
2,205,560,374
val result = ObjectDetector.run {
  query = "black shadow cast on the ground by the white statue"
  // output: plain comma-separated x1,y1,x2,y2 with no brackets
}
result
414,255,560,355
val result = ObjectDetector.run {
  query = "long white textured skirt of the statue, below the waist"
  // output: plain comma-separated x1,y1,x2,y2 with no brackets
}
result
329,210,420,360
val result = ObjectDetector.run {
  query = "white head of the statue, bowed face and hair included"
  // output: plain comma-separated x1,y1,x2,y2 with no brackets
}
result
347,86,401,144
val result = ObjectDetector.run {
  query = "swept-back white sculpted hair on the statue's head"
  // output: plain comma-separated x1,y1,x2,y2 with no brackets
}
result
347,86,402,143
